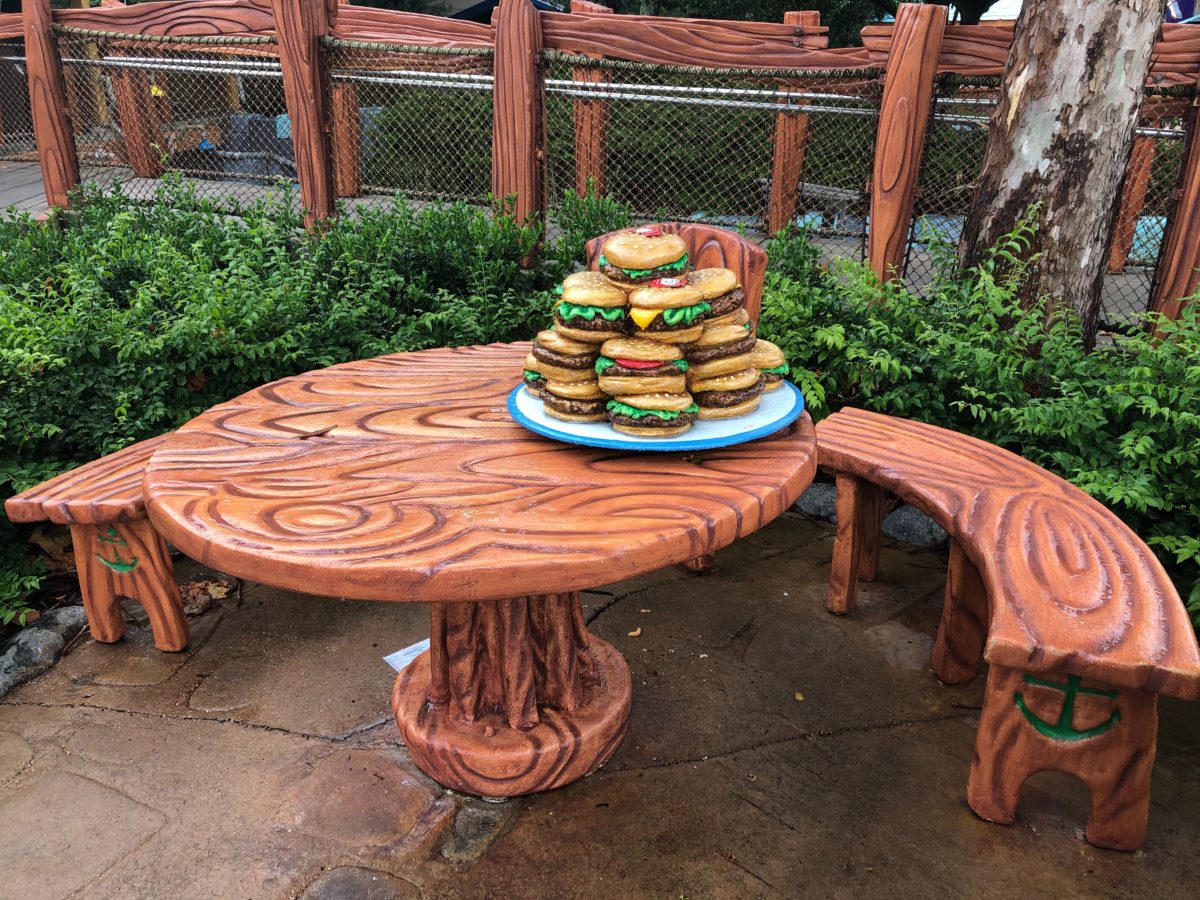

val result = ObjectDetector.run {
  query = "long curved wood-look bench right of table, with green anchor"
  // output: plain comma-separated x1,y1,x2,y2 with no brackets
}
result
817,409,1200,850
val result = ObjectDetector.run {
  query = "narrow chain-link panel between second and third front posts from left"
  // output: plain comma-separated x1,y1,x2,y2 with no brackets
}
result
325,38,493,203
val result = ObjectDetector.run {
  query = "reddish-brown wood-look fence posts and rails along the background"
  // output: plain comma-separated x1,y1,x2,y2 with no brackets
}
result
16,0,1200,324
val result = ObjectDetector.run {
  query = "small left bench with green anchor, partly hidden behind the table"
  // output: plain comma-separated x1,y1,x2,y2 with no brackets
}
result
4,437,188,650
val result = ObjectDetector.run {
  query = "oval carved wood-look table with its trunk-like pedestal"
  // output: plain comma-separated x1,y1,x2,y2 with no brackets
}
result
145,343,816,797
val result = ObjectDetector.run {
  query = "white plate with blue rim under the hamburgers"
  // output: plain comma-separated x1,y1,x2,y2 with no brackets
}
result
509,382,804,452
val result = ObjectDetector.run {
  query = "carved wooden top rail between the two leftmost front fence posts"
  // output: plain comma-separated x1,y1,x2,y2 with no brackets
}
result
54,0,275,36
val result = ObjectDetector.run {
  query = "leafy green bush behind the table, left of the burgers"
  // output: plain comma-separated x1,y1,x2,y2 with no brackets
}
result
0,181,628,620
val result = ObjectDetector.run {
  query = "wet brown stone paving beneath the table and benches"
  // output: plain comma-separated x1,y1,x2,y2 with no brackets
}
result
0,516,1200,900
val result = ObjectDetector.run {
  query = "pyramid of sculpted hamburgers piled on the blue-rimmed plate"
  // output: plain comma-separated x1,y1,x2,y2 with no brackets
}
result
524,226,787,438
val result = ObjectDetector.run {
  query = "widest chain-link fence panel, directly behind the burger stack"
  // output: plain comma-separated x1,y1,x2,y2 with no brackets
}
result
544,53,880,257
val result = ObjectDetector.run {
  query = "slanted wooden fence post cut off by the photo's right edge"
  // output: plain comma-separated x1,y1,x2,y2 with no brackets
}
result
1150,90,1200,319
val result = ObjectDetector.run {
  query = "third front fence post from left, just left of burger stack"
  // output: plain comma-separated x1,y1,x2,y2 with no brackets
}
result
492,0,542,222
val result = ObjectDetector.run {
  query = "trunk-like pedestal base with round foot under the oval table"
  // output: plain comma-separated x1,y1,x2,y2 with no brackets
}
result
391,593,632,797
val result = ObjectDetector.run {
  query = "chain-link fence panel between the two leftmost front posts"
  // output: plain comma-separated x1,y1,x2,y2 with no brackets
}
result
56,26,299,210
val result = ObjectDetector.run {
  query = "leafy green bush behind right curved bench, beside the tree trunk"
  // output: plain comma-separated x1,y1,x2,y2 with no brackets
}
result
760,221,1200,624
